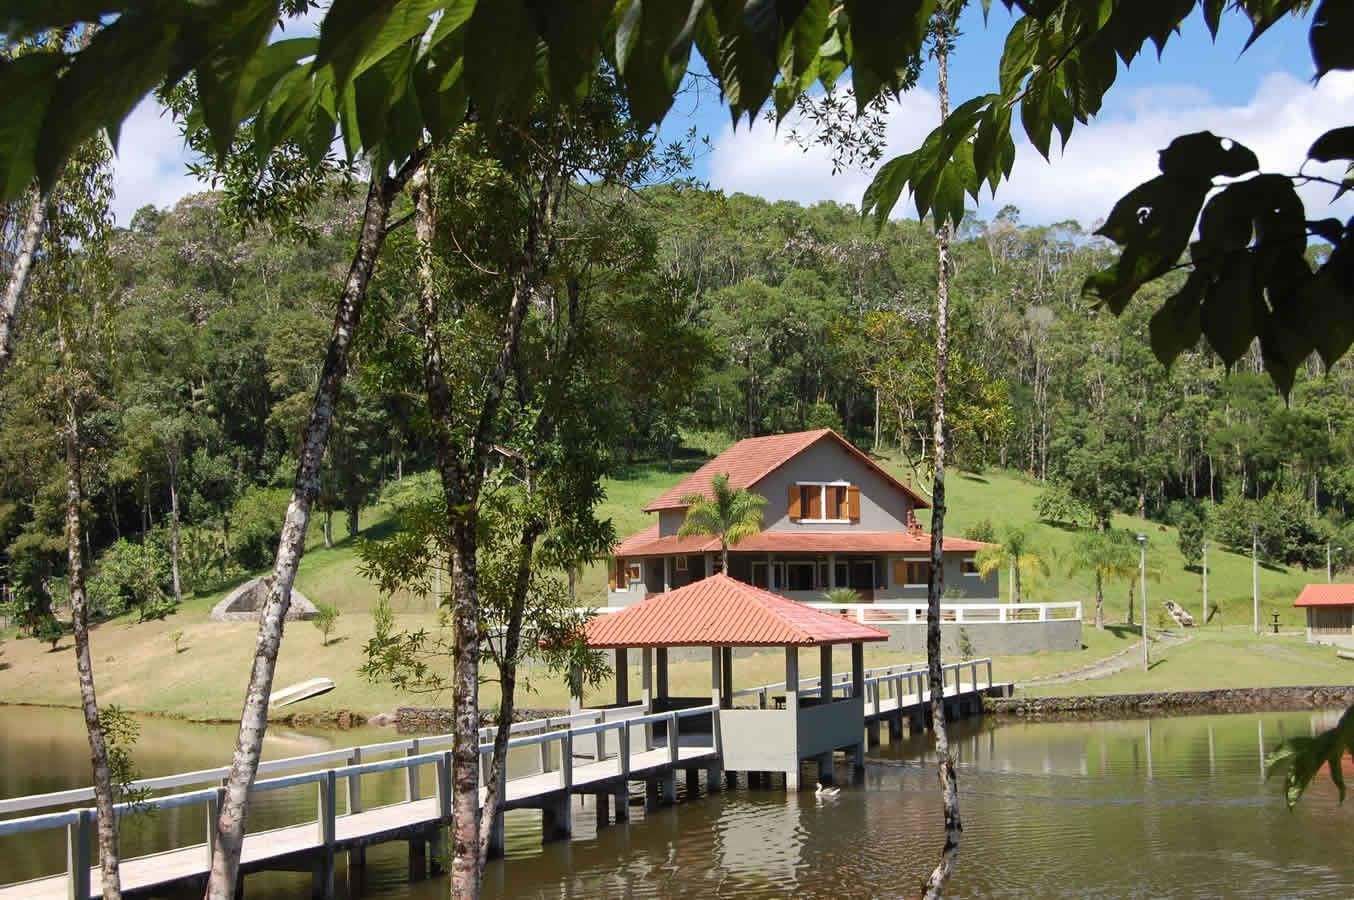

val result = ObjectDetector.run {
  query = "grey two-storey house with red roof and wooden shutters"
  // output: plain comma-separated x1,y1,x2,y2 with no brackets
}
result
609,428,998,606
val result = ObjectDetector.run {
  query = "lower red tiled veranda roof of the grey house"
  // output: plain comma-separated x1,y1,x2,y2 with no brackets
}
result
612,525,987,556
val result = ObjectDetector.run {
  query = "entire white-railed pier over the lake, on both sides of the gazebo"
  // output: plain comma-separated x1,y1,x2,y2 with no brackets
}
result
0,655,1011,900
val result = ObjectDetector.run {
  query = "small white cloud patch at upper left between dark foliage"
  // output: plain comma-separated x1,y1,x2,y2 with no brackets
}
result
112,97,204,225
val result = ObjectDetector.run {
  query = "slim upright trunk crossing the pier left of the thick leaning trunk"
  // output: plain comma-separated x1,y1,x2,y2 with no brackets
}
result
62,384,122,900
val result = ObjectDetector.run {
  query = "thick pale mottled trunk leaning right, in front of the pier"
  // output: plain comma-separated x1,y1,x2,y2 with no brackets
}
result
207,152,422,900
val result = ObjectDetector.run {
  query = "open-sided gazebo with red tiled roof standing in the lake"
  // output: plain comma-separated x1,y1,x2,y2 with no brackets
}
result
586,574,888,790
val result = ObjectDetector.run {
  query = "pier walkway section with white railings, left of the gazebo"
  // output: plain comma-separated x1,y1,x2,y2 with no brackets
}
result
0,706,723,900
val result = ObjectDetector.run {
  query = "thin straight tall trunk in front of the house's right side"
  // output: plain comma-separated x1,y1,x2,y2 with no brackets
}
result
926,19,964,899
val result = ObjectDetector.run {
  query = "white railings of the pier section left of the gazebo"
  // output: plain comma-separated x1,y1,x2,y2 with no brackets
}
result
0,705,722,897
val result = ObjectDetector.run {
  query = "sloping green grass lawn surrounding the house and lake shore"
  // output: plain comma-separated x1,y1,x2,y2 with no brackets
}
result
0,441,1354,720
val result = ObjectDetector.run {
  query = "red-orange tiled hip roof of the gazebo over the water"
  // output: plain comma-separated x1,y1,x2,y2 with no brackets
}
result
586,574,888,647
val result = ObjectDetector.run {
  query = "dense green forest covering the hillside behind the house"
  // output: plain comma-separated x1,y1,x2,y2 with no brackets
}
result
0,181,1354,633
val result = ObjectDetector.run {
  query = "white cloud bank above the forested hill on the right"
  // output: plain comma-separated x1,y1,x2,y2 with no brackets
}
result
709,72,1354,225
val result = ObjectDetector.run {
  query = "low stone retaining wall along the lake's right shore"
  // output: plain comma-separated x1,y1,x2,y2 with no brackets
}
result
983,685,1354,719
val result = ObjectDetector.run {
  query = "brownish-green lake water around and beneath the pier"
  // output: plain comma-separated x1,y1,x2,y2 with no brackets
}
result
0,706,1354,900
